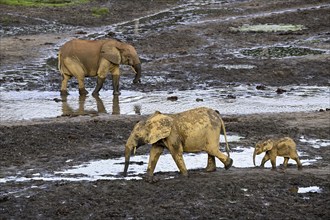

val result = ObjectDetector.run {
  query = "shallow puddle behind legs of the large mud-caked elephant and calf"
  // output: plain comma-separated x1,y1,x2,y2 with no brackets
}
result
0,147,316,183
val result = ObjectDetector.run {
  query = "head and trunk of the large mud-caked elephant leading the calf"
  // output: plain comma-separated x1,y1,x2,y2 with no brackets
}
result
124,111,173,176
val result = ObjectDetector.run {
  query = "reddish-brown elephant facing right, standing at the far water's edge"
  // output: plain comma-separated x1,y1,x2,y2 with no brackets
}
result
58,39,141,95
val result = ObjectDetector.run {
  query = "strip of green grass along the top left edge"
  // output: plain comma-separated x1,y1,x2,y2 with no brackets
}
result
0,0,89,6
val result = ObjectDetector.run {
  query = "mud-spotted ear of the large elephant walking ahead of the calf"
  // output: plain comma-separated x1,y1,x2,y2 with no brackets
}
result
146,111,173,144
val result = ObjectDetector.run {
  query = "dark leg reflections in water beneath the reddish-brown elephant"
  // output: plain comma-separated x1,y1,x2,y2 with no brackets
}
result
61,95,120,117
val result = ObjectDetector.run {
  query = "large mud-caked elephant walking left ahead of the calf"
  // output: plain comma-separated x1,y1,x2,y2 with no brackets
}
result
124,107,233,181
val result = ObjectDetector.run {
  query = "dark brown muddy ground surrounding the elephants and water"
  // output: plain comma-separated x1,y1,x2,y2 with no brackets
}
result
0,0,330,219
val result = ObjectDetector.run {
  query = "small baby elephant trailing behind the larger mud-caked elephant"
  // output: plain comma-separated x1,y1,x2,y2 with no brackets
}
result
253,137,302,170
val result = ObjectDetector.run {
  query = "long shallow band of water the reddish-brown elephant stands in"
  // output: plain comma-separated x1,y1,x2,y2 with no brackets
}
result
0,85,330,121
